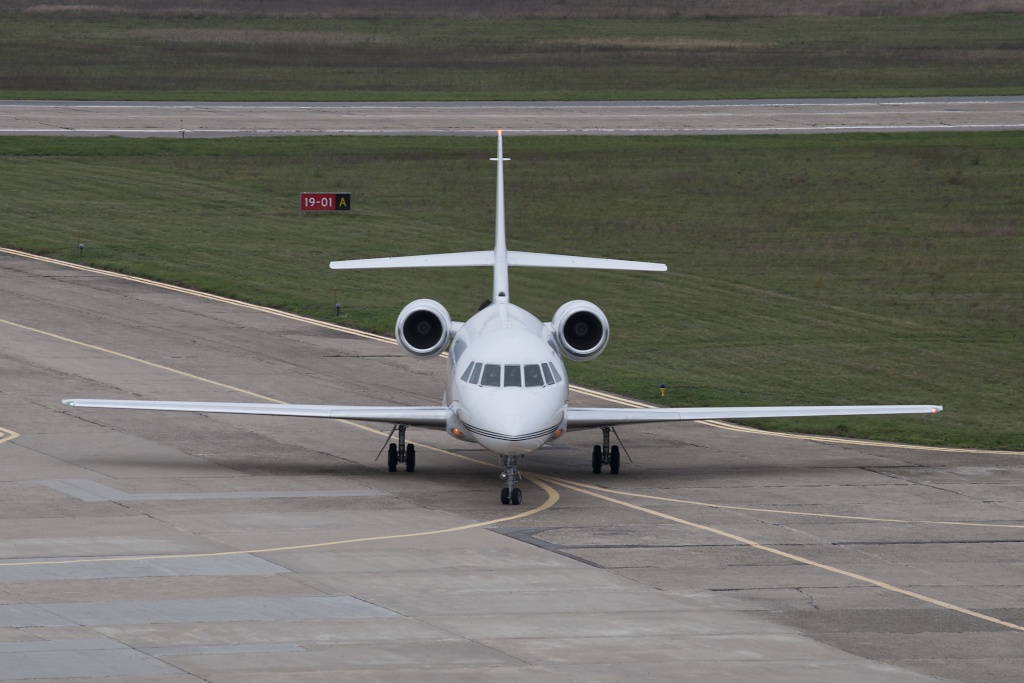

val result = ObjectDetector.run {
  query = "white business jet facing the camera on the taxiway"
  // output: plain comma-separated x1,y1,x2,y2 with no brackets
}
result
63,131,942,505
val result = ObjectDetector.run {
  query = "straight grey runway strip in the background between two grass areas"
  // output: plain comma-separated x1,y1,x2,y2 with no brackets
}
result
0,97,1024,137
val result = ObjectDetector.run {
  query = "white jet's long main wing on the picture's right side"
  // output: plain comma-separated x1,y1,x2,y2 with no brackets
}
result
565,405,942,430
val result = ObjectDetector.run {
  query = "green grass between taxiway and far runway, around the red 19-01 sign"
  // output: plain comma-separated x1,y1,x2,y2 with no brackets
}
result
0,133,1024,450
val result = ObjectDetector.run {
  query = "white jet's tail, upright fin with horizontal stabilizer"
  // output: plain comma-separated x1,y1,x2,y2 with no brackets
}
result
331,130,668,303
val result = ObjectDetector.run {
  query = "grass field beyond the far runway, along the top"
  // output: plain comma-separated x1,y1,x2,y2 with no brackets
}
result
0,9,1024,100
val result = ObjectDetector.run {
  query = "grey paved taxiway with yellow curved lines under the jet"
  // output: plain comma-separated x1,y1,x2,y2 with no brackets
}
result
0,251,1024,683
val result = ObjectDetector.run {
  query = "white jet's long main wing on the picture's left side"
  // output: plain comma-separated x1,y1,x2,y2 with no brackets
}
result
62,398,449,429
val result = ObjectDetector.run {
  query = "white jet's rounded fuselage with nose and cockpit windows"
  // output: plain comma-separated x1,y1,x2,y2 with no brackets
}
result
445,302,568,456
